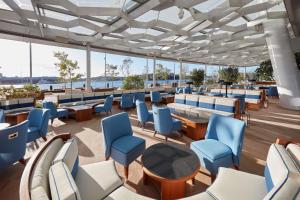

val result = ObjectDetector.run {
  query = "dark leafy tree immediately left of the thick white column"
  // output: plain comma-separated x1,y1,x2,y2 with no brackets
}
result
255,60,274,81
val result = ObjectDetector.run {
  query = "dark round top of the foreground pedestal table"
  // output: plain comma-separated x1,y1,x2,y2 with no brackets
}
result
142,143,200,179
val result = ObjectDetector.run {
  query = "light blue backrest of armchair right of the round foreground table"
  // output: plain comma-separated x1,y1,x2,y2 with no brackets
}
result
205,114,245,165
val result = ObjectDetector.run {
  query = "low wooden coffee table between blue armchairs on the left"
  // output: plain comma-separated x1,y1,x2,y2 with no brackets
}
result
63,105,93,122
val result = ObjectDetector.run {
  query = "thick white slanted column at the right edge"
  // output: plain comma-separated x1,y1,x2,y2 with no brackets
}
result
264,19,300,110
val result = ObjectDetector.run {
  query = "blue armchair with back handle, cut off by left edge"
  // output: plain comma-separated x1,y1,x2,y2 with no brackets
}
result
0,120,28,171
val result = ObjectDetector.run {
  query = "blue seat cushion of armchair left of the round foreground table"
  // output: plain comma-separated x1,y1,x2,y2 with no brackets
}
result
112,136,145,154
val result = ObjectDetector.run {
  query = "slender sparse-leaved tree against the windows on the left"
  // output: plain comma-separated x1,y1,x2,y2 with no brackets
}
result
54,51,82,90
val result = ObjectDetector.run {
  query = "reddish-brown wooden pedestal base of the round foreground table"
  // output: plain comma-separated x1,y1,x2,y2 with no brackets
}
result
161,181,185,200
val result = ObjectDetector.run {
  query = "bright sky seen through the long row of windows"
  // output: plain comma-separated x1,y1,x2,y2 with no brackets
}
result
0,39,256,77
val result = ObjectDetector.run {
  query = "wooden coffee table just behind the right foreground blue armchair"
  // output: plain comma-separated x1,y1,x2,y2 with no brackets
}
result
171,109,211,140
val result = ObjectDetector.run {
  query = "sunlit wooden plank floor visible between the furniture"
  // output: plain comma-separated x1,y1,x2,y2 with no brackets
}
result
0,99,300,200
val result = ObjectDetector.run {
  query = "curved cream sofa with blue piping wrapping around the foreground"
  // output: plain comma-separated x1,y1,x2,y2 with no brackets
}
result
20,135,300,200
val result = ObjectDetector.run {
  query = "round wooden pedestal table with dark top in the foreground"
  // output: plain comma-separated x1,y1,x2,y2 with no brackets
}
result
142,143,200,200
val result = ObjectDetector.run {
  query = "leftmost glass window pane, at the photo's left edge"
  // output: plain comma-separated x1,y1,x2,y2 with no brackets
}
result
0,39,30,87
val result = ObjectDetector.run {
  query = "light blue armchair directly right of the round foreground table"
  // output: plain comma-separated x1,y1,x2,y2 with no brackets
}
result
191,114,245,179
